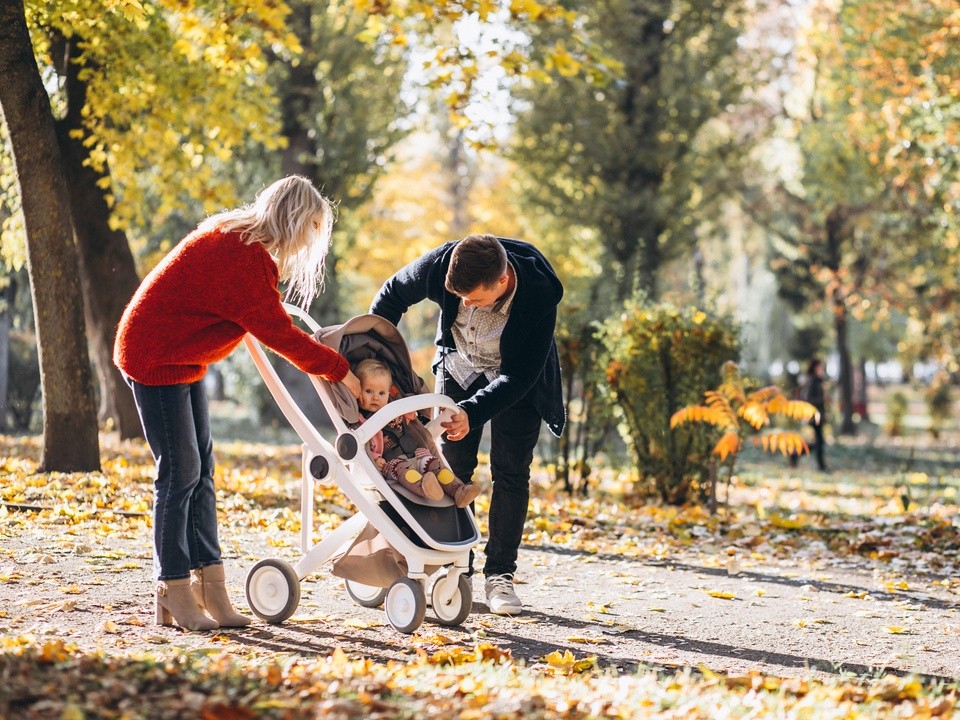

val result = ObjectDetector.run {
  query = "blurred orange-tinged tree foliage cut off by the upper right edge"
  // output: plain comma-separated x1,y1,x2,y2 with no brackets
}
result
835,0,960,360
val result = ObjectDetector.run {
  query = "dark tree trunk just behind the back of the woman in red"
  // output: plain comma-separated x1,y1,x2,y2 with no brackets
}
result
57,38,143,440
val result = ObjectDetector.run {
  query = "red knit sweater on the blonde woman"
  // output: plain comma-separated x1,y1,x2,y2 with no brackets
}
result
113,231,349,385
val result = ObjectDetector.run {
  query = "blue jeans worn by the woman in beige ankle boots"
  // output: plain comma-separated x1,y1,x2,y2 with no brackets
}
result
127,379,222,580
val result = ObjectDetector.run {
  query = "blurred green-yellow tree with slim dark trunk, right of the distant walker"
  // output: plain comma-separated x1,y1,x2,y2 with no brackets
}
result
747,2,957,434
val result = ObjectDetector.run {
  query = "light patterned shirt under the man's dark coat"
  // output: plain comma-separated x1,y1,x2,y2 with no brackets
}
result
444,262,517,389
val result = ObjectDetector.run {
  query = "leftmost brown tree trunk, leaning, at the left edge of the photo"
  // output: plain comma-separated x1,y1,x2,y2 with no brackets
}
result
0,0,100,472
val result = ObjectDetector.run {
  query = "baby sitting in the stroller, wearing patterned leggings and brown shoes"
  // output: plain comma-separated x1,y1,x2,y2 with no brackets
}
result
354,358,480,508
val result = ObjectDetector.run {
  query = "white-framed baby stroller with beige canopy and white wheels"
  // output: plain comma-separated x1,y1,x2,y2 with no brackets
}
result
244,305,479,633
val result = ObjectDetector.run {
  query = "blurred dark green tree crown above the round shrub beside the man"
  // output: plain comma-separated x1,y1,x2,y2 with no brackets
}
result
515,0,746,299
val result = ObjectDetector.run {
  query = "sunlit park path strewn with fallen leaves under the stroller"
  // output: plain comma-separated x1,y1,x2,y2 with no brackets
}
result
0,524,960,678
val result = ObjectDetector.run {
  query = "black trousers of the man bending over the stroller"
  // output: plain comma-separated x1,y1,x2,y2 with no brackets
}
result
441,375,540,576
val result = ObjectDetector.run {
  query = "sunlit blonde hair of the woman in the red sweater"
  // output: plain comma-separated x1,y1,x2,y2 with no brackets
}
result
199,175,335,310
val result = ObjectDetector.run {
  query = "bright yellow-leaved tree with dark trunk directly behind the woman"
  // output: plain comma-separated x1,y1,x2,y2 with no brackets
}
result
12,0,300,438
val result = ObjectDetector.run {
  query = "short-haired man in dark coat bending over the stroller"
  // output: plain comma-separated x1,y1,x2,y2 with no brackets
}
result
370,235,566,614
